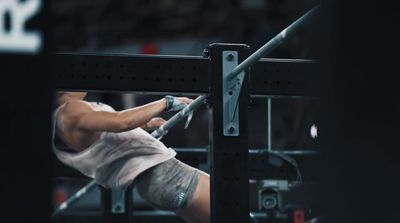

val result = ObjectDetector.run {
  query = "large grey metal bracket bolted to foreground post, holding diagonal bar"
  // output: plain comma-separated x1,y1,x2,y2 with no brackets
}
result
222,51,244,136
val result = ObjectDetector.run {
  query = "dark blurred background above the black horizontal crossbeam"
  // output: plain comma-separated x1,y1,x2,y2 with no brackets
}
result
52,0,316,58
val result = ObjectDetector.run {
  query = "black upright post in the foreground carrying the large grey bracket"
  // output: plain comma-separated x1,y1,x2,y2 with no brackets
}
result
207,44,250,223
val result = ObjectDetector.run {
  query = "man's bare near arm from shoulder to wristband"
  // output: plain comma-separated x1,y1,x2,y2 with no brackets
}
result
66,99,166,132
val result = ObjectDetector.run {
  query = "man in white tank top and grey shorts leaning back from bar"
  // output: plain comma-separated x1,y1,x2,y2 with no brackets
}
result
53,92,210,223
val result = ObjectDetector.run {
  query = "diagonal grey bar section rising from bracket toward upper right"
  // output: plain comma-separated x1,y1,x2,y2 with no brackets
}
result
227,6,318,79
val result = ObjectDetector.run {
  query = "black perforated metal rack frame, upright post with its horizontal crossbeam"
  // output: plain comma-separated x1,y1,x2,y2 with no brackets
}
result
53,44,318,223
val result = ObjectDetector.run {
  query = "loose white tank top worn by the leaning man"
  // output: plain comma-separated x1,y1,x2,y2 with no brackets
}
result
52,103,176,189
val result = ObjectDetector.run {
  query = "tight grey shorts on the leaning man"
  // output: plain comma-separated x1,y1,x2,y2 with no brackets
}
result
135,158,199,211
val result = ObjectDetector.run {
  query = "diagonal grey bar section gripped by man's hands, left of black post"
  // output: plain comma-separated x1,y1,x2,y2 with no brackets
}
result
151,95,207,138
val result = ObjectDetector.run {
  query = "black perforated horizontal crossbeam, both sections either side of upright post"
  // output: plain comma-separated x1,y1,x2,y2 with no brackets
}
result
53,54,323,97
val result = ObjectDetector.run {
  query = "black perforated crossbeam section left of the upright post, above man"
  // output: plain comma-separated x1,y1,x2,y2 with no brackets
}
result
52,53,210,94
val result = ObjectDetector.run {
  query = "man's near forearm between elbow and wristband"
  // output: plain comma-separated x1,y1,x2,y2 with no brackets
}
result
118,98,166,130
